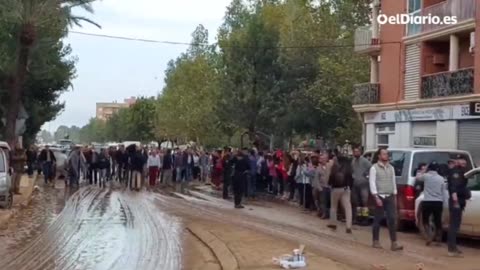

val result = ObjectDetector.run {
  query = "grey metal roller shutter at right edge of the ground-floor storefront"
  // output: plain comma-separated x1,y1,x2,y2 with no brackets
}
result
458,120,480,165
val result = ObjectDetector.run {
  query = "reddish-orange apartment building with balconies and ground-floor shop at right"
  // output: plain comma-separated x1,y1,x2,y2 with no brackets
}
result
353,0,480,164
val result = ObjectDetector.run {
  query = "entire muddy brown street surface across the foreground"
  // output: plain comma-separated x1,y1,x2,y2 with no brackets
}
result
0,180,480,270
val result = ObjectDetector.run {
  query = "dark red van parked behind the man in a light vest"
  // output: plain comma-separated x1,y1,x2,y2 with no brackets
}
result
364,148,474,230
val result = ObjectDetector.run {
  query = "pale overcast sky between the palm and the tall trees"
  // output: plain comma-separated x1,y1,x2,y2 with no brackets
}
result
43,0,231,132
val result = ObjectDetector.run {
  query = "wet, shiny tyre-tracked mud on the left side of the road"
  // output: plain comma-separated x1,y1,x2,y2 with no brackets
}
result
0,186,182,270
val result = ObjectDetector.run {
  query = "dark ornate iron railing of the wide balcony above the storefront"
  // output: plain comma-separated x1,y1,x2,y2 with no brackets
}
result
420,68,474,98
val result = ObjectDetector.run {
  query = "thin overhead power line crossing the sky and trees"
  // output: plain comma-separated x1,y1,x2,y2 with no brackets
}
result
69,31,401,49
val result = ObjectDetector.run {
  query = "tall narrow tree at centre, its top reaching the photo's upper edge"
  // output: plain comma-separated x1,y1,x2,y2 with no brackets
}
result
219,1,287,142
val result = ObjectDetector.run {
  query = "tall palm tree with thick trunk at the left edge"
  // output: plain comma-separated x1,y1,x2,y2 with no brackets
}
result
0,0,100,146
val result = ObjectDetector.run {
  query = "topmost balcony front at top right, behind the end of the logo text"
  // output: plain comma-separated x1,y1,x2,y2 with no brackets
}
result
422,0,476,33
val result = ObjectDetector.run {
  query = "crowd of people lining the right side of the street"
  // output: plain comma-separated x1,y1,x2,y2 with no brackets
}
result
212,147,469,257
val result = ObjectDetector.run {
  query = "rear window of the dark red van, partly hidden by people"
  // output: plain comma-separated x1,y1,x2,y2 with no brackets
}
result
411,151,473,176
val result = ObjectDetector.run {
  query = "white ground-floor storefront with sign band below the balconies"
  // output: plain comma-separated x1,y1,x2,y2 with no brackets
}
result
364,103,480,162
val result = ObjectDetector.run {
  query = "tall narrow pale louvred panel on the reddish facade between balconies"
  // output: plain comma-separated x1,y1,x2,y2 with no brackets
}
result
404,44,421,100
